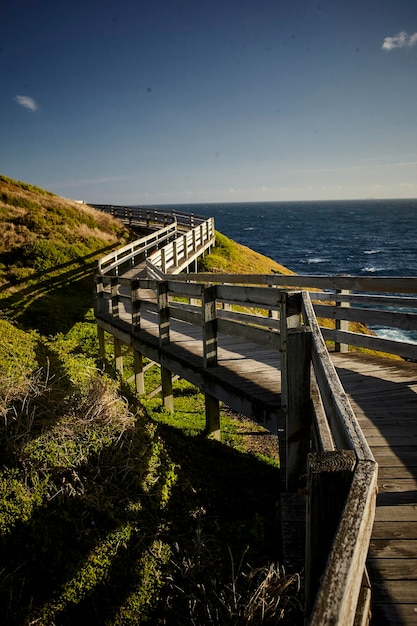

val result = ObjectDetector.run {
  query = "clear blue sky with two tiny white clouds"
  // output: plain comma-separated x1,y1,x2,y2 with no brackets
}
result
0,0,417,204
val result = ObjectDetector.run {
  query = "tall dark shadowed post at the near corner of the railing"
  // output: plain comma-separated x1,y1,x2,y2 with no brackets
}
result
285,329,312,491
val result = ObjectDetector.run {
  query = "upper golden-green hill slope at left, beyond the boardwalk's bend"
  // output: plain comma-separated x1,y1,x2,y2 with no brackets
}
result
0,176,129,334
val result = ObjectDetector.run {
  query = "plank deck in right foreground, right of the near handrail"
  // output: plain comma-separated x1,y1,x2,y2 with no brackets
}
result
332,352,417,626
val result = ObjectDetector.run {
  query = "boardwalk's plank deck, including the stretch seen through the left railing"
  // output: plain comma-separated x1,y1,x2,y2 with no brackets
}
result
98,294,417,626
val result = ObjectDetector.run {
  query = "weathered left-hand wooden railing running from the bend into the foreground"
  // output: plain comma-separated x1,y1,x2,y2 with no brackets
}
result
97,276,377,626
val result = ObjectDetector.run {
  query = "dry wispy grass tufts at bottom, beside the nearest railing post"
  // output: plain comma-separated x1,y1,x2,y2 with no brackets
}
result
158,529,301,626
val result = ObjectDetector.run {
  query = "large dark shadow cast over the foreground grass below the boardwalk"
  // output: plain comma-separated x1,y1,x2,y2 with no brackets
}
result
0,398,281,626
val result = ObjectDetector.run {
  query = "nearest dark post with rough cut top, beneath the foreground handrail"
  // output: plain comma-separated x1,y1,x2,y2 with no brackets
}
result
305,450,354,617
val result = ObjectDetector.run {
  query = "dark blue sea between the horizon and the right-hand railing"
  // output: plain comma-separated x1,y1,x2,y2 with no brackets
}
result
146,199,417,276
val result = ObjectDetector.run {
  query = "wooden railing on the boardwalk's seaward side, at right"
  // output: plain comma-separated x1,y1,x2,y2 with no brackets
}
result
172,273,417,361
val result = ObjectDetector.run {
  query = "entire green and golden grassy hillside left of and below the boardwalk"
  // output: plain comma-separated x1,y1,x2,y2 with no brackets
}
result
0,177,298,626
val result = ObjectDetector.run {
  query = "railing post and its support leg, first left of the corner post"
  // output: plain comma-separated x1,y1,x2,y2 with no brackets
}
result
201,285,221,441
